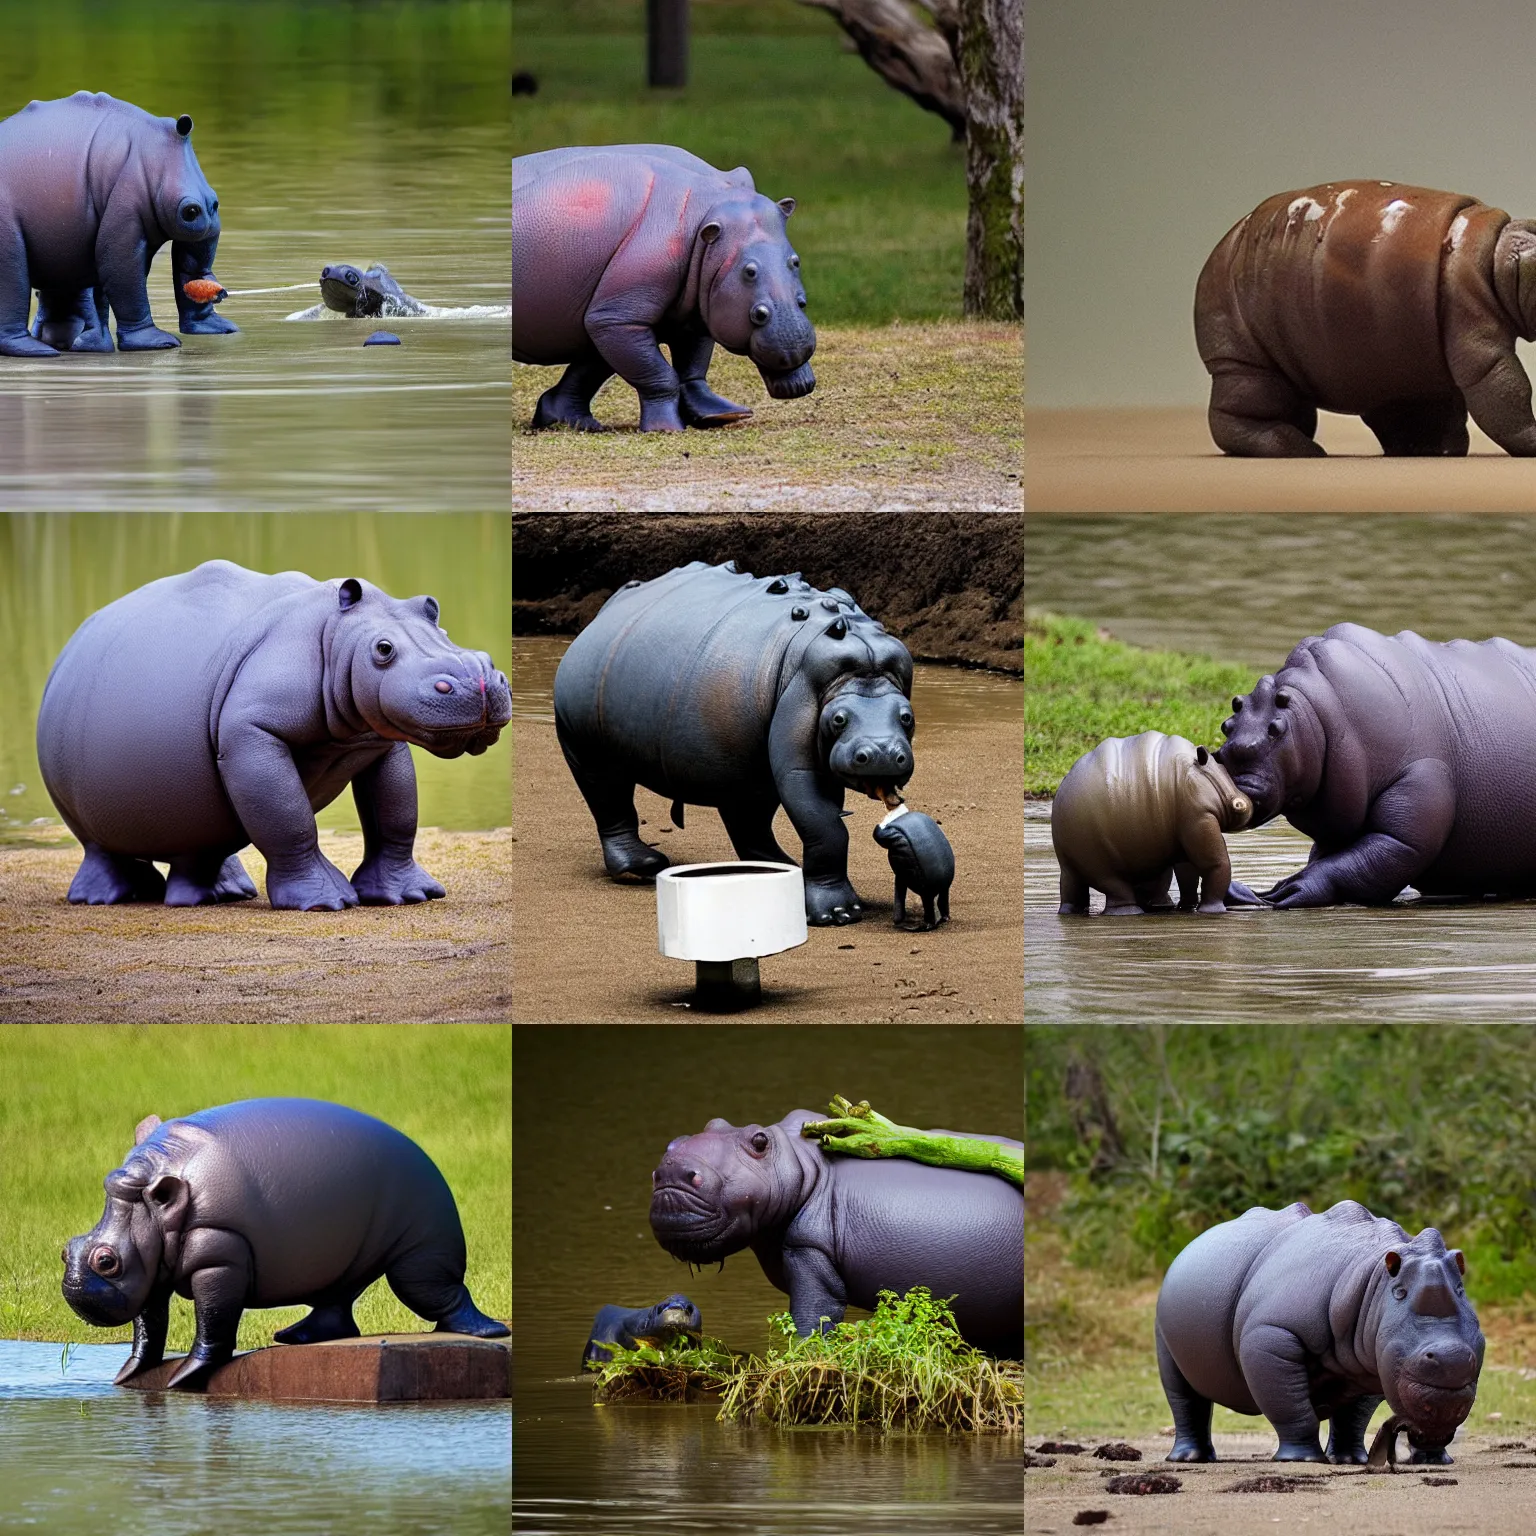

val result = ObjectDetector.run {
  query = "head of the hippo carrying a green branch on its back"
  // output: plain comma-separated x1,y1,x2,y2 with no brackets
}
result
651,1120,805,1264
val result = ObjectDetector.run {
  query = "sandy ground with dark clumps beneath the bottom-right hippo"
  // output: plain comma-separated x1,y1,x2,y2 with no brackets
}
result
1025,1435,1536,1536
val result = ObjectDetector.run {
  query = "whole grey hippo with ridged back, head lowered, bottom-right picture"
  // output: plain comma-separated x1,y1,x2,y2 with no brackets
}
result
1157,1200,1482,1462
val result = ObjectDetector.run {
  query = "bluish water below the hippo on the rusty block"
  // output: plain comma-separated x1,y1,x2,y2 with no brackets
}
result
0,1341,511,1536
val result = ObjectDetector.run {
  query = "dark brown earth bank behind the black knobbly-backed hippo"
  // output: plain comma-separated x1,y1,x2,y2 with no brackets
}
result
511,511,1025,673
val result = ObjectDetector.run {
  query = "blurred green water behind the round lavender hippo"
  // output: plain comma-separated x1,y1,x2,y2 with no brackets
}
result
0,513,511,839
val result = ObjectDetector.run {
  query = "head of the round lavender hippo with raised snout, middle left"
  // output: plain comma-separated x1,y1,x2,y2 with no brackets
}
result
326,576,511,757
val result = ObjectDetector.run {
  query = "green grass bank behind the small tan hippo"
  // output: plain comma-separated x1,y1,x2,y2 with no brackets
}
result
1025,613,1253,794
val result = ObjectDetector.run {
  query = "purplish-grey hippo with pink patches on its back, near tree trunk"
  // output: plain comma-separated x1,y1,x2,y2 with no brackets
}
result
511,144,816,432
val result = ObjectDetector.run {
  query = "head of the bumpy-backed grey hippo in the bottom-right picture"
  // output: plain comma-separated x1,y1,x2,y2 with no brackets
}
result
1376,1227,1482,1450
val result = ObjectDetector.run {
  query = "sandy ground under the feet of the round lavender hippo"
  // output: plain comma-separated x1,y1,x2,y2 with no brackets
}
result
0,829,511,1025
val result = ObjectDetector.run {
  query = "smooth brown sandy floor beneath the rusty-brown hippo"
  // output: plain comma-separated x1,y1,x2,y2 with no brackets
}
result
1025,406,1536,513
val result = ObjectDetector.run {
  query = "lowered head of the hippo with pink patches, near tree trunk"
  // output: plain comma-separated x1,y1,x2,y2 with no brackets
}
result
699,194,816,399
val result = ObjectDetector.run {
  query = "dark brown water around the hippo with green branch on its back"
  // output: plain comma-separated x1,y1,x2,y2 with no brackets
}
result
513,1025,1023,1536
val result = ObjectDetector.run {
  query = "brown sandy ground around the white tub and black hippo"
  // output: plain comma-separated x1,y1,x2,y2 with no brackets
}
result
513,722,1023,1025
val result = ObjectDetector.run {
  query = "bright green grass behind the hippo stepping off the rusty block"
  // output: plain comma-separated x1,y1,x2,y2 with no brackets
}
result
0,1025,511,1350
